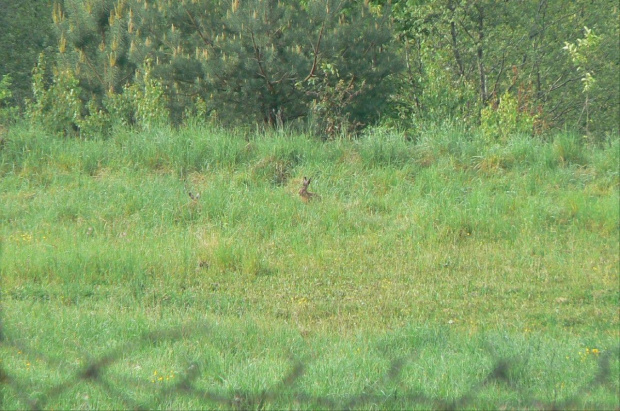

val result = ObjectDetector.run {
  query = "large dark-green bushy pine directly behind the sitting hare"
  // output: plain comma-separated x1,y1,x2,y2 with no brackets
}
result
132,0,399,131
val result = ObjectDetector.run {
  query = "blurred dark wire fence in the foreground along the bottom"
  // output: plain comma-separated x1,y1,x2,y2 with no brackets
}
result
0,318,620,410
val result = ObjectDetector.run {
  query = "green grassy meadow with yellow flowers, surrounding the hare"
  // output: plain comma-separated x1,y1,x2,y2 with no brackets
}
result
0,125,620,409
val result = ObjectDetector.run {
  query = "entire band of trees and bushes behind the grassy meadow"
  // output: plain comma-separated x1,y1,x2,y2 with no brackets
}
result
0,0,620,140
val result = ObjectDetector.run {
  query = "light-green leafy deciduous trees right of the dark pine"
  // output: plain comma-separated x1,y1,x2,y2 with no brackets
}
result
393,0,620,138
